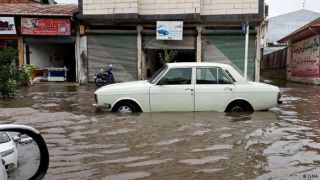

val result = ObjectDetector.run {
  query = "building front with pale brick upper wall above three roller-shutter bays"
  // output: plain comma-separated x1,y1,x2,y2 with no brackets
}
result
77,0,265,83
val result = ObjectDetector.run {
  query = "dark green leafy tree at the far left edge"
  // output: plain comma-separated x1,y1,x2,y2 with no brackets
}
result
0,47,18,98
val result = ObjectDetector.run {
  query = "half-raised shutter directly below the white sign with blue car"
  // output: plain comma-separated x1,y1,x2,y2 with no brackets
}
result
143,36,196,50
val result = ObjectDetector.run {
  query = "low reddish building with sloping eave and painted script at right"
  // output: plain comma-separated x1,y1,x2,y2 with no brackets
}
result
279,18,320,84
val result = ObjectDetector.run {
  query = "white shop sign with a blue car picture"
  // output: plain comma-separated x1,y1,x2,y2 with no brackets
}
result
157,21,183,40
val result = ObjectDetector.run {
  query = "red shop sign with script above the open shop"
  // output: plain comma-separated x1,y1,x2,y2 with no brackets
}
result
21,18,71,36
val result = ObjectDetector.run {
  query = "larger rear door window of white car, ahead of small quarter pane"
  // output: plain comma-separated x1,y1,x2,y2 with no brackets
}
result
197,67,218,84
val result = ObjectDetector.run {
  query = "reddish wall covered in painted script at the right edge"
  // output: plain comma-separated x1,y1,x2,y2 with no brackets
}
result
291,35,320,77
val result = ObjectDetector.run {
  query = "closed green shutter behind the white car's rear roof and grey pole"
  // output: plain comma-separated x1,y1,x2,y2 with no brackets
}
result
202,33,256,79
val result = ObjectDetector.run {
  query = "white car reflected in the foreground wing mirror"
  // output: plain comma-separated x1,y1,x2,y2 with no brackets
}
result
0,132,18,170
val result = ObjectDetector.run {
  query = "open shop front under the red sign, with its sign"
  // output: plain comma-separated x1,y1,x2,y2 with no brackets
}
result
21,18,77,82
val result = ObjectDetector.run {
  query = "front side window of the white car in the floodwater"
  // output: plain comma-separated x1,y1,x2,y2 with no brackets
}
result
158,68,192,85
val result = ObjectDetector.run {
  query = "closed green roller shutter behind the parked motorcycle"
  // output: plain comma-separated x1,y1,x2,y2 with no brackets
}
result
88,34,138,82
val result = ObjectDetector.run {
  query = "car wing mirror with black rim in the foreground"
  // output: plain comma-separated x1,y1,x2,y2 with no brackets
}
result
0,125,49,180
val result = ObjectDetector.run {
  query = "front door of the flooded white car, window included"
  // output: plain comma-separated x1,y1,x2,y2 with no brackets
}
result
150,67,194,112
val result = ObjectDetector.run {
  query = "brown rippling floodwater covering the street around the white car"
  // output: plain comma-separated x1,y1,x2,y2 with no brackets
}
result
0,84,320,180
